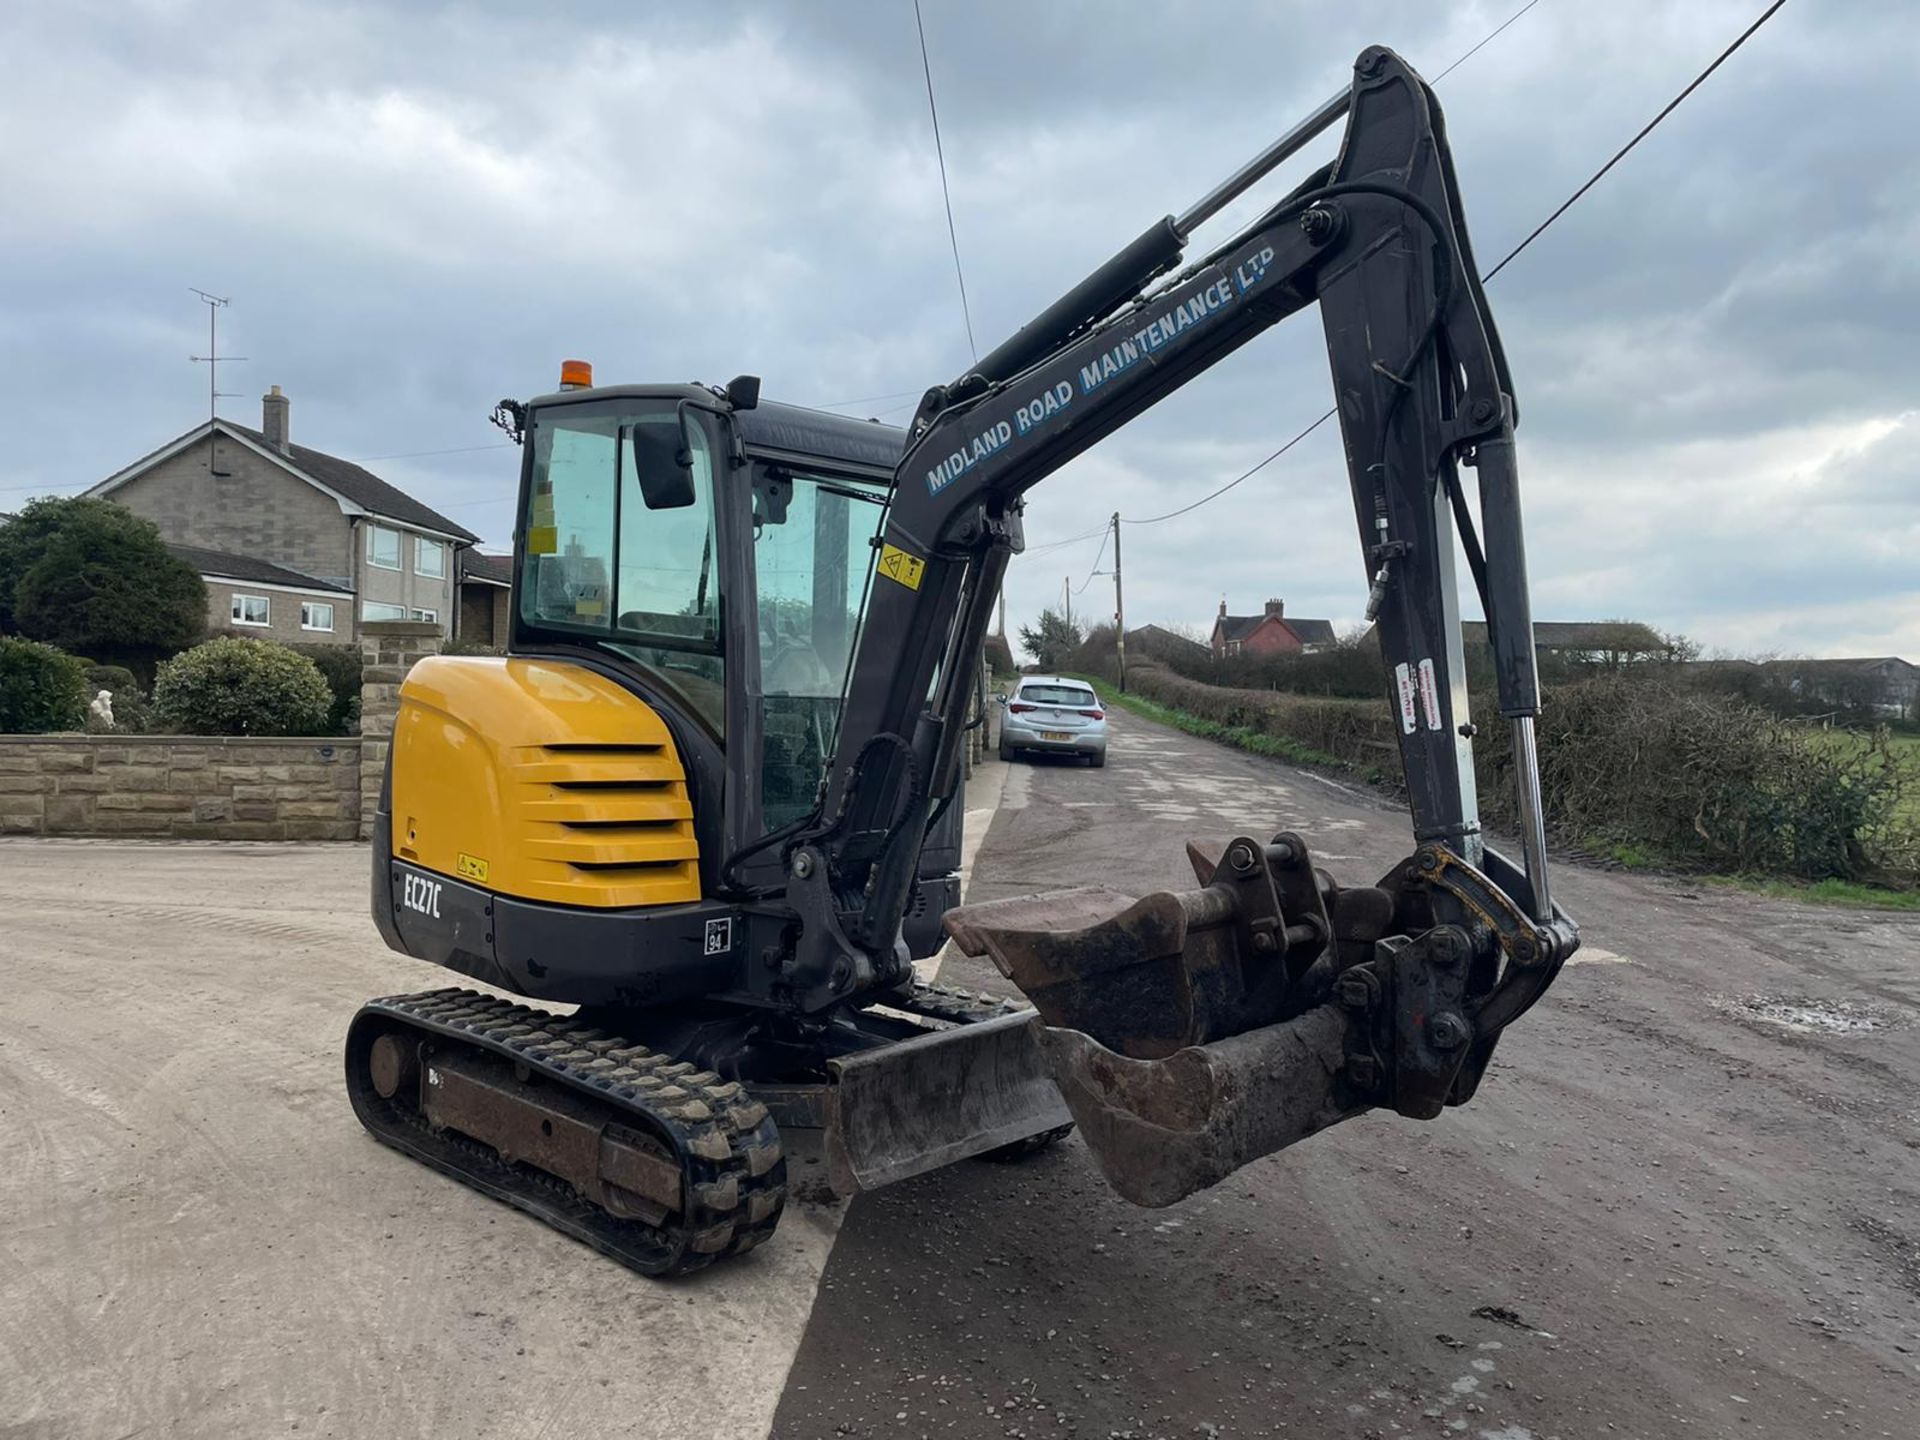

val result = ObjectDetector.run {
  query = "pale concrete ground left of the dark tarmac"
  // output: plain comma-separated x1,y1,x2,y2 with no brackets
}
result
0,841,837,1440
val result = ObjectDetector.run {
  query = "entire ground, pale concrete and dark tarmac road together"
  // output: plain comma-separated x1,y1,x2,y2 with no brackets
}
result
0,714,1920,1440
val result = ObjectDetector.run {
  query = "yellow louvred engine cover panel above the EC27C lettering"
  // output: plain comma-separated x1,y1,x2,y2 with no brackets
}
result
394,655,701,908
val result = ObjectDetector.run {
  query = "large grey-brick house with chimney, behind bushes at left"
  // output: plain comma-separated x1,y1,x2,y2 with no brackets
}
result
86,386,478,641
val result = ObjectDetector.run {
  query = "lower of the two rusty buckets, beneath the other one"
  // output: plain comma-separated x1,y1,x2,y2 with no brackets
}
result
1043,1006,1369,1208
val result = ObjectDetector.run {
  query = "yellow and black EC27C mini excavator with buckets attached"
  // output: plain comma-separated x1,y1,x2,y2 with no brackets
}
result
346,48,1578,1275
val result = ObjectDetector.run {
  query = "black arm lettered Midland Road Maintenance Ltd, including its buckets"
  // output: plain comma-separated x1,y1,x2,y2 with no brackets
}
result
781,48,1578,1204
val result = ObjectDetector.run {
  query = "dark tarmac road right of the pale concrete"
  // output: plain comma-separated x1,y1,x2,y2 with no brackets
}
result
774,714,1920,1440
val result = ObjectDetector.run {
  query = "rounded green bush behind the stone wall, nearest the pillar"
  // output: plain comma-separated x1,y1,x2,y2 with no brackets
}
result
154,639,334,735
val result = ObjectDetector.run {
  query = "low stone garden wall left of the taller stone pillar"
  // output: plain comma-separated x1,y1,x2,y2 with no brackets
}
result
0,735,361,841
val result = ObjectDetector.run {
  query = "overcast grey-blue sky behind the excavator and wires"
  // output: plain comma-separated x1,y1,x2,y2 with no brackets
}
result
0,0,1920,660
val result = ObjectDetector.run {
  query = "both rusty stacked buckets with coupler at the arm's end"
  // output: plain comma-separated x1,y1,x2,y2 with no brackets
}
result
945,833,1572,1206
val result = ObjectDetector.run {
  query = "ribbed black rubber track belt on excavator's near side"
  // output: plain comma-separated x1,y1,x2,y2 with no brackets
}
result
346,989,787,1277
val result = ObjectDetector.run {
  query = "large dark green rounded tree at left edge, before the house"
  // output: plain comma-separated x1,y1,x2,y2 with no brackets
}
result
0,497,207,674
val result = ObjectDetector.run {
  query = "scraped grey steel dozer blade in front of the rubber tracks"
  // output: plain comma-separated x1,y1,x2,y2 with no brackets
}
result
824,1010,1073,1194
